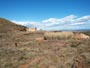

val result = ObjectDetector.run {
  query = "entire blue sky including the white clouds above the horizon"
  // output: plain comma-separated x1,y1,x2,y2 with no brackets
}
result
0,0,90,30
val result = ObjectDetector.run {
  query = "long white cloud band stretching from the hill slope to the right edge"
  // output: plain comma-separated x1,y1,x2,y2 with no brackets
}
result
10,15,90,29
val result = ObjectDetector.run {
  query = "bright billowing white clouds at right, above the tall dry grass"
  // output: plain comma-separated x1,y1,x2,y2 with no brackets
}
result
42,15,90,26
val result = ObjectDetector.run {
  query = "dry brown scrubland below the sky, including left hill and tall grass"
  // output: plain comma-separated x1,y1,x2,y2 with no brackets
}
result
0,18,90,68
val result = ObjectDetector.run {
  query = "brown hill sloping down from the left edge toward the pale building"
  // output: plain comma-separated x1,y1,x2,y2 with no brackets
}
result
0,18,26,33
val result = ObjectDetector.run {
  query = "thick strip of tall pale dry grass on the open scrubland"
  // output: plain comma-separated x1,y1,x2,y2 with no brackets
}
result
44,32,74,40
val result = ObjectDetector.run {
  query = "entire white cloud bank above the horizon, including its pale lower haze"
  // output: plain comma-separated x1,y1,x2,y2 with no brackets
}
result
12,15,90,30
